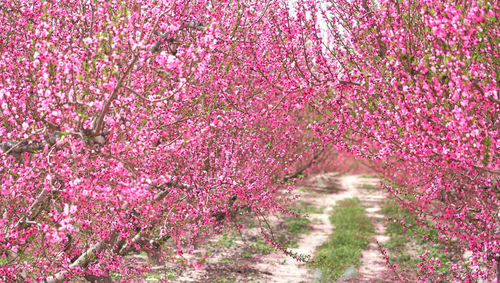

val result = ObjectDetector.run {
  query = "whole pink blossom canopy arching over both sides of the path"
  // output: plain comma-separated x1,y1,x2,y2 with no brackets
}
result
0,0,500,282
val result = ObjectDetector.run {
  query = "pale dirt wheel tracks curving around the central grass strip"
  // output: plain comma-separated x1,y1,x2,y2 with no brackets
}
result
255,173,387,282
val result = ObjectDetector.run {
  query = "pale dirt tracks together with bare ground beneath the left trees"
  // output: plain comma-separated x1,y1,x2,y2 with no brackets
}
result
153,173,389,283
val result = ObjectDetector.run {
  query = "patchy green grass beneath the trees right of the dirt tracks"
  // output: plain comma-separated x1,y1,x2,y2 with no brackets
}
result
382,201,449,274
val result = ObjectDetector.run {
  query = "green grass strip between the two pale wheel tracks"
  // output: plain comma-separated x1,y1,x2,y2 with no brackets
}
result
312,198,374,280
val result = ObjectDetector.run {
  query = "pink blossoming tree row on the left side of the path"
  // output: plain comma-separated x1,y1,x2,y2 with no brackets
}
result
0,0,323,282
